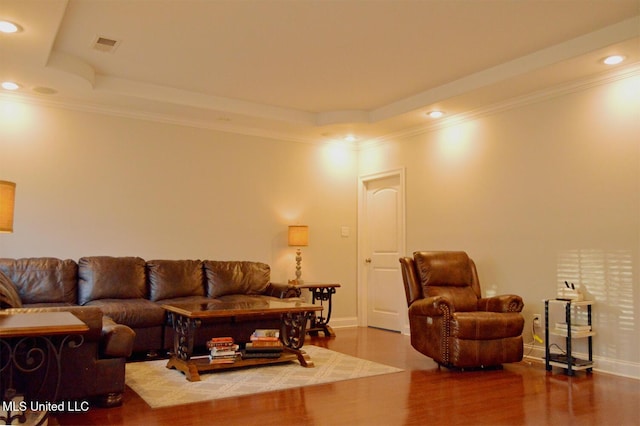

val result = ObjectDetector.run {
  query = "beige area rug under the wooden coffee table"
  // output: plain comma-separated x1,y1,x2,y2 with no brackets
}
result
126,346,402,408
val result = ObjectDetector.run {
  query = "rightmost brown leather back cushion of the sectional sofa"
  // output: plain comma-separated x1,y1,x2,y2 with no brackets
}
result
204,260,271,297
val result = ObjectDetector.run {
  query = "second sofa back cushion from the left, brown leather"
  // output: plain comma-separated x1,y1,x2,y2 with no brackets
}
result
78,256,147,304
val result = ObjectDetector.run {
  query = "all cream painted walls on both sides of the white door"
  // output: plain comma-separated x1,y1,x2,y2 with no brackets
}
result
0,70,640,377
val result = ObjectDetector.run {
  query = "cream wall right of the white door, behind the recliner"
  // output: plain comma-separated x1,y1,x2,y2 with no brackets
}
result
359,73,640,377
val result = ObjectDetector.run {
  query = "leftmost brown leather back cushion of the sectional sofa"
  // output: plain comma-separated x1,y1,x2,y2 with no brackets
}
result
0,257,78,305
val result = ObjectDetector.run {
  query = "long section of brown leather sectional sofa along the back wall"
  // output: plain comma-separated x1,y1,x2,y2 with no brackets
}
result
0,256,300,352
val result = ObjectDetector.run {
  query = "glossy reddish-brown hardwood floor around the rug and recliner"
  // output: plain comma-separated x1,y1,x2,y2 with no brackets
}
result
55,328,640,426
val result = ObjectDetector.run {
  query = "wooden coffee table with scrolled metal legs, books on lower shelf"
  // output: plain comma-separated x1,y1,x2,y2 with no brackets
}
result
162,298,322,382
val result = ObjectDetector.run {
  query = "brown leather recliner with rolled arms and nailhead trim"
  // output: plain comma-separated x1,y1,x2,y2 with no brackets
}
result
400,251,524,368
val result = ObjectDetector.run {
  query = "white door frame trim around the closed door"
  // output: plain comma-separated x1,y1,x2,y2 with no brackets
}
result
357,167,407,331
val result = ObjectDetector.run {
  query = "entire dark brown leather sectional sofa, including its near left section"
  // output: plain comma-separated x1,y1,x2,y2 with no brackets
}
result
0,256,300,405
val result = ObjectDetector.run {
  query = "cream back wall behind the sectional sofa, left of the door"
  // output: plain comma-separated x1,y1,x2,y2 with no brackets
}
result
0,98,357,318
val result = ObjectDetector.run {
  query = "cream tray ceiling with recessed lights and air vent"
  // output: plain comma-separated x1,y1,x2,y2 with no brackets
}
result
0,0,640,141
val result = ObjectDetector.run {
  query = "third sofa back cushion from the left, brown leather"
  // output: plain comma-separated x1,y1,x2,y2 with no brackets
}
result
147,260,204,302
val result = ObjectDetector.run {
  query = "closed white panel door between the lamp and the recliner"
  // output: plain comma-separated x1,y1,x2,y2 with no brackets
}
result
361,173,407,331
